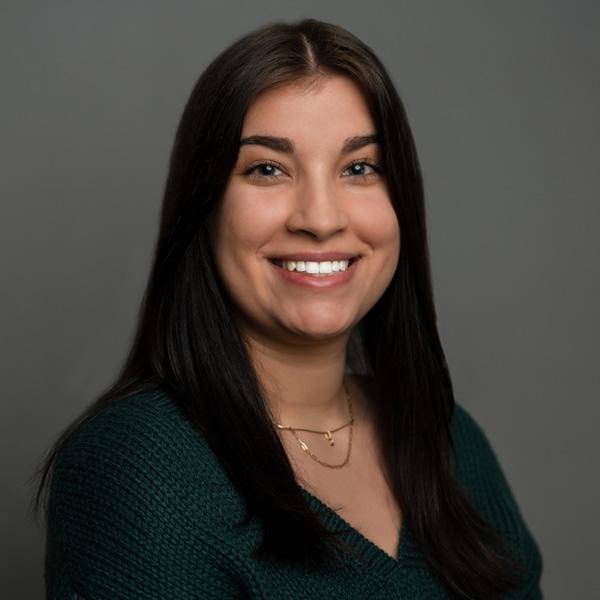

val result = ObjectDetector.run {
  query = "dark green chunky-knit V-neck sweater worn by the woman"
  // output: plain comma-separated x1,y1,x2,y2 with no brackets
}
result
45,392,542,600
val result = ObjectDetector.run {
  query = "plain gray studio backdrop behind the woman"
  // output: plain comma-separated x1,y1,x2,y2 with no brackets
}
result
0,0,600,599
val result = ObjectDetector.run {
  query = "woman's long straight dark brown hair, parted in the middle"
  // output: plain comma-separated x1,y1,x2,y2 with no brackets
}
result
33,19,520,599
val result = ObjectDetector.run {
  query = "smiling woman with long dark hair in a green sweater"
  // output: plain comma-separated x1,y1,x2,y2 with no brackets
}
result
31,19,541,600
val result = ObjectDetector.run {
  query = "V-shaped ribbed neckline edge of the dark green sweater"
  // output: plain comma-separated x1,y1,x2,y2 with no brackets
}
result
298,484,424,577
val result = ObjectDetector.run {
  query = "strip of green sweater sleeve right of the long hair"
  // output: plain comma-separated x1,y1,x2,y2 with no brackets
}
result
451,404,543,600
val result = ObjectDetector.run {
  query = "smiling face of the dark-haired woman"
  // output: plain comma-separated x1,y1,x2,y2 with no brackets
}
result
212,76,400,344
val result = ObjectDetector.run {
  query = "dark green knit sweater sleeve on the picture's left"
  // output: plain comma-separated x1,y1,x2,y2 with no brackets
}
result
45,398,246,600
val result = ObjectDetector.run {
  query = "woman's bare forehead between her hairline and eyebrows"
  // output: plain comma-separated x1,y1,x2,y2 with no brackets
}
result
242,76,374,150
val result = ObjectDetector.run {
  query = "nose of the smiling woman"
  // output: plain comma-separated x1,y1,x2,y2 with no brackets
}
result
286,179,348,239
